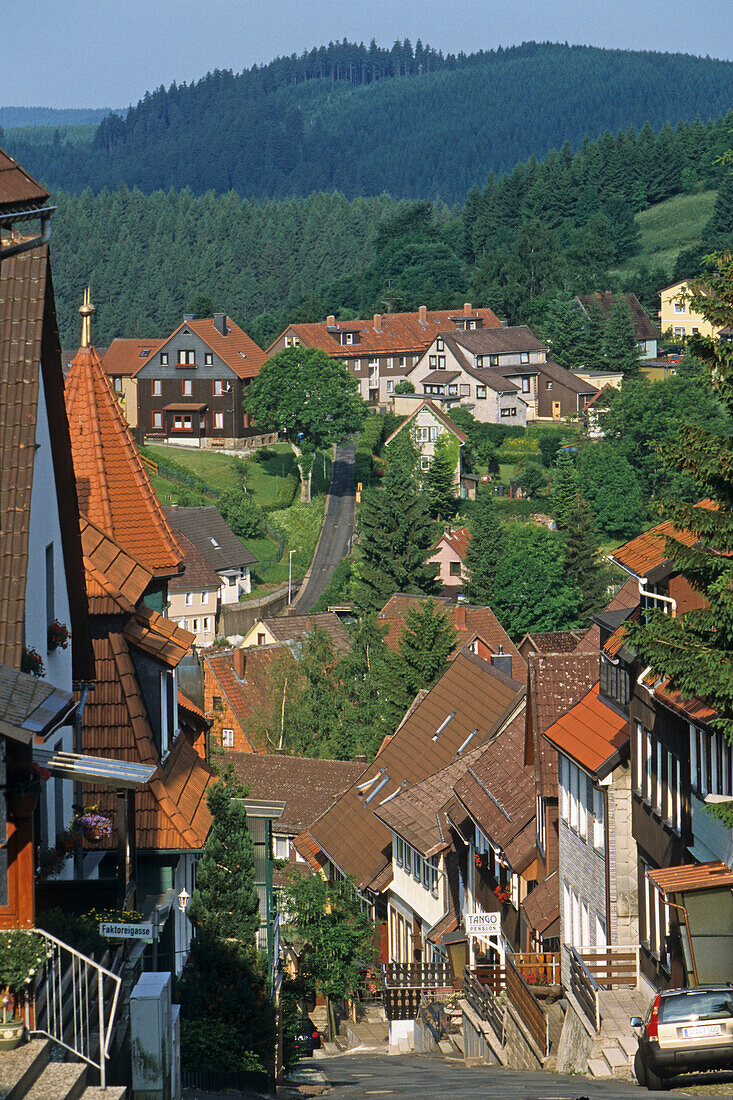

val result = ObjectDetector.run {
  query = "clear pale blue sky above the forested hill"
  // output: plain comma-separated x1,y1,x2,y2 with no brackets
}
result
0,0,733,108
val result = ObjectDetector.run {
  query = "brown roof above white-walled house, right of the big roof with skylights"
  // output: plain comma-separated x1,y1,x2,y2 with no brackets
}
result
374,747,483,857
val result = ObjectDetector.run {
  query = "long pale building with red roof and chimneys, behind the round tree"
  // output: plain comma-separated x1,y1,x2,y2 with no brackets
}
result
266,301,501,406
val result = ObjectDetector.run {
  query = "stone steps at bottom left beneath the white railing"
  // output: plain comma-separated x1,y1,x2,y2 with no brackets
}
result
0,1038,128,1100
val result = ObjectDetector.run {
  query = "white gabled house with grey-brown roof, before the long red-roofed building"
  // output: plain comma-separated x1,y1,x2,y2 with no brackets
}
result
408,325,595,427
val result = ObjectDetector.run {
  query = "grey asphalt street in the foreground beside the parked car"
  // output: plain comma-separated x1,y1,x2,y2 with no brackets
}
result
315,1054,647,1100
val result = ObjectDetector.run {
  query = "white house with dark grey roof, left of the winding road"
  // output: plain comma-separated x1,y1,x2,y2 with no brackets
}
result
164,505,258,602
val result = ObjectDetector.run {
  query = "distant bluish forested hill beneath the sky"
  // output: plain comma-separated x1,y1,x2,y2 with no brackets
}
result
4,42,733,201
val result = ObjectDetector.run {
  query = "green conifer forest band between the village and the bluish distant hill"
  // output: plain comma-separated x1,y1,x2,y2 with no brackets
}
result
47,102,733,347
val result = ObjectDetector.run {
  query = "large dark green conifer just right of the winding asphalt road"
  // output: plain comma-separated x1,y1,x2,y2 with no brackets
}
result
352,462,436,611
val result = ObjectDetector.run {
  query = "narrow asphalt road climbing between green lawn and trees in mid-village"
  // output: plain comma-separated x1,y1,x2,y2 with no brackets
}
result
296,443,357,615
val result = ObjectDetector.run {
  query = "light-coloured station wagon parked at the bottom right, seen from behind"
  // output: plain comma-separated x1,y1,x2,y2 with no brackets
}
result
631,982,733,1090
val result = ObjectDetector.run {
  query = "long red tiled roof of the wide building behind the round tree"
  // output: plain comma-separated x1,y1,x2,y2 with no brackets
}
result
267,309,501,359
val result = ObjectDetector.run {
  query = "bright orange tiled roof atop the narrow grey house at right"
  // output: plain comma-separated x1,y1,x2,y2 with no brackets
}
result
545,684,628,773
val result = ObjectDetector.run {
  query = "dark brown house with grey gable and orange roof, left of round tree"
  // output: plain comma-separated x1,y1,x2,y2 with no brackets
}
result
105,314,270,448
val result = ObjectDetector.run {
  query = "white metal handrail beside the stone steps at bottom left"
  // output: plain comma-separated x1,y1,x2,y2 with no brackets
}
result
25,928,122,1089
